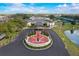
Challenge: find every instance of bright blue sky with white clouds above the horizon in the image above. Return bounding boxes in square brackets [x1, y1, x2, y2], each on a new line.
[0, 3, 79, 14]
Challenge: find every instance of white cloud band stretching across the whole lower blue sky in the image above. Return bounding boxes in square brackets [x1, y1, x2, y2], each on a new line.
[0, 3, 79, 14]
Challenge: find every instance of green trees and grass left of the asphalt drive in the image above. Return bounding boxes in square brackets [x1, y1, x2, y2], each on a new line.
[0, 19, 26, 47]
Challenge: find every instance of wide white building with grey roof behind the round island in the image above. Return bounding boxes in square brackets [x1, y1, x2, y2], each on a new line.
[27, 16, 55, 28]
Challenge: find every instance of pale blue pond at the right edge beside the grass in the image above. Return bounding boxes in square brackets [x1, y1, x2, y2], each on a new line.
[64, 30, 79, 46]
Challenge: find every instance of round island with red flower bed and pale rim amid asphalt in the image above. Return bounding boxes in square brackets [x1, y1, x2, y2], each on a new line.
[23, 31, 53, 50]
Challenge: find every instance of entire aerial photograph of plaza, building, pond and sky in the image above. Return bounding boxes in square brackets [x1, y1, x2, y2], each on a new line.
[0, 3, 79, 56]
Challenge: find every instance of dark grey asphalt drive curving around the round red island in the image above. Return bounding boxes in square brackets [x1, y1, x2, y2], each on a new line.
[0, 29, 69, 56]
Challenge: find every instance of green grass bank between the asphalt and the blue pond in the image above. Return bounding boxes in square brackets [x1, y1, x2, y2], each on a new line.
[53, 24, 79, 56]
